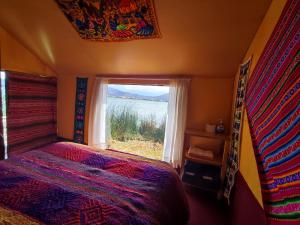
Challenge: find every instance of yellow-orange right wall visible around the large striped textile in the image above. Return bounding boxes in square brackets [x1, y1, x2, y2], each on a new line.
[234, 0, 286, 205]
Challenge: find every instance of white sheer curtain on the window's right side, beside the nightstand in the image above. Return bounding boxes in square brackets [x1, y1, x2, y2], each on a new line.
[163, 79, 189, 168]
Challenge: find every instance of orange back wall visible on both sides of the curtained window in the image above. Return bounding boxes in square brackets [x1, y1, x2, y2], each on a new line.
[58, 76, 233, 142]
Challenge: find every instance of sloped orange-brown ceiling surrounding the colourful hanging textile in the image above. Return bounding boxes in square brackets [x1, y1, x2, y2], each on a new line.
[0, 0, 271, 77]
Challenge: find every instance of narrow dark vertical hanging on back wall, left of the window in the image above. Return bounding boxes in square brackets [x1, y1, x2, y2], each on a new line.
[73, 77, 88, 144]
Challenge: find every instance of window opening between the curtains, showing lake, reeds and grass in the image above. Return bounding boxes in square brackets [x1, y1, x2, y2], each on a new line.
[106, 84, 169, 160]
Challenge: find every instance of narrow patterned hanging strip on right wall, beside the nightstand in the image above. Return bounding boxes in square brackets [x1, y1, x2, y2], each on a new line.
[224, 57, 252, 203]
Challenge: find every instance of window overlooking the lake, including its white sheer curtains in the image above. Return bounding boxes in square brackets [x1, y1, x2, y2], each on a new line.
[88, 77, 189, 167]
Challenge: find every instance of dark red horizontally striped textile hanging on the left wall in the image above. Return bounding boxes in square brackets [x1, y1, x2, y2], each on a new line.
[7, 72, 57, 155]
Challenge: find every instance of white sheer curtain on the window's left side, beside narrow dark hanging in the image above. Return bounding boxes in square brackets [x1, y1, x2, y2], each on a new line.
[88, 77, 108, 148]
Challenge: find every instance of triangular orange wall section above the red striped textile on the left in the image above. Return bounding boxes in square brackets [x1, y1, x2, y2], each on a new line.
[0, 27, 55, 76]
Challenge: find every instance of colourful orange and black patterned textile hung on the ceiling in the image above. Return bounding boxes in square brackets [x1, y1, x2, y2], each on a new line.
[55, 0, 160, 41]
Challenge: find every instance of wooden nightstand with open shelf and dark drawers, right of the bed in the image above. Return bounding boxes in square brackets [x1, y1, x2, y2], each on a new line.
[181, 130, 229, 198]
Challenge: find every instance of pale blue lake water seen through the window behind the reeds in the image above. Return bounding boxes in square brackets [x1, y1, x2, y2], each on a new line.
[107, 97, 168, 124]
